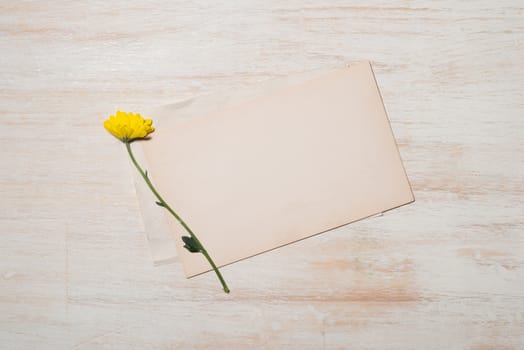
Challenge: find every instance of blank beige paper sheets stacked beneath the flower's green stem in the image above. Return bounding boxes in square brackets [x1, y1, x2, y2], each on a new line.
[138, 62, 414, 277]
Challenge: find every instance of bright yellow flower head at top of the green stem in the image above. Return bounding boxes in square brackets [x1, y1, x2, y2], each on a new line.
[104, 111, 155, 142]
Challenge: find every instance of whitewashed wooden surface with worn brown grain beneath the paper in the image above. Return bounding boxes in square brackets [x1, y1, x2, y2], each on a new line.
[0, 0, 524, 350]
